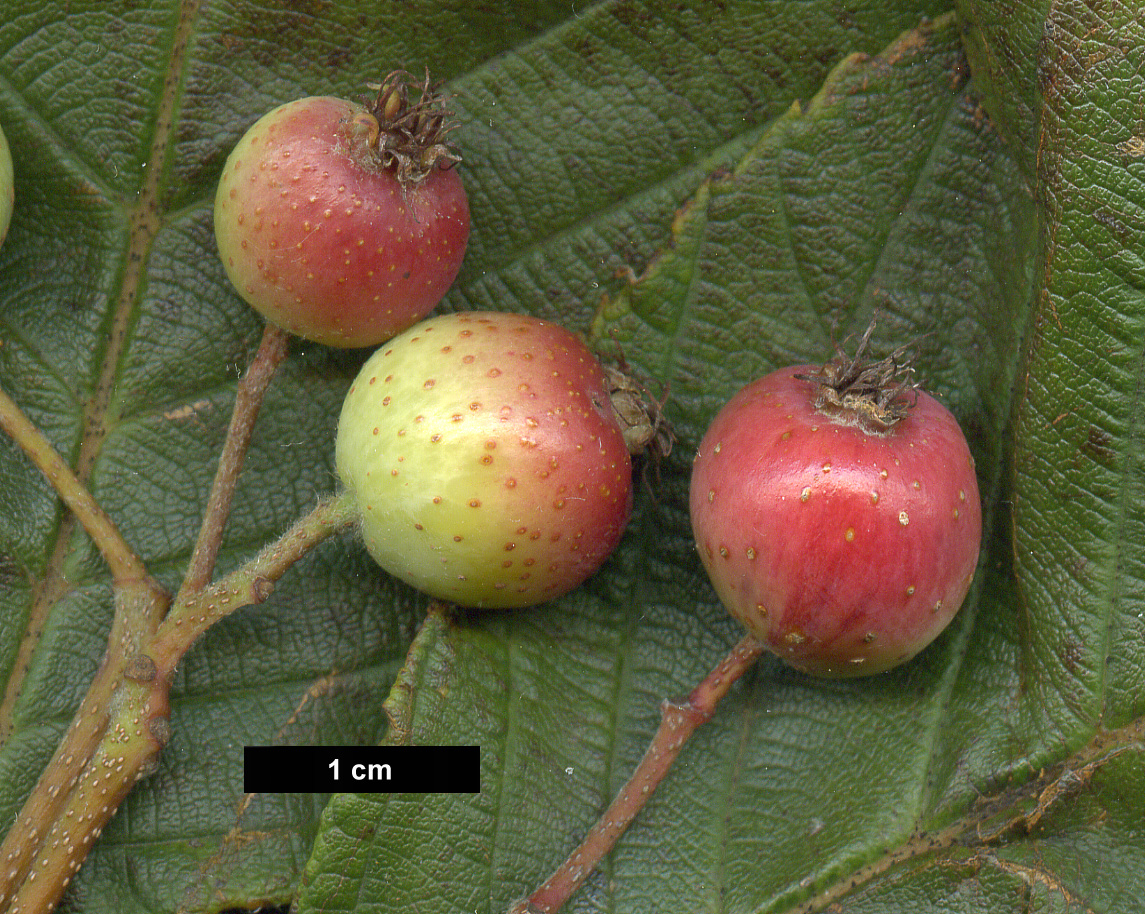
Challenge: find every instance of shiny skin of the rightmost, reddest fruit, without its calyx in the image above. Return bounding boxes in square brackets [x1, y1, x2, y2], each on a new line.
[689, 365, 982, 677]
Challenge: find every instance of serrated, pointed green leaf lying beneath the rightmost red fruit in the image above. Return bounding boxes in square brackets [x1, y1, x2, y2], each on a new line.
[301, 10, 1140, 912]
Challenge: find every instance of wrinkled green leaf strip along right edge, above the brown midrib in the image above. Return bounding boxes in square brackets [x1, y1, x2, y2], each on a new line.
[975, 3, 1145, 740]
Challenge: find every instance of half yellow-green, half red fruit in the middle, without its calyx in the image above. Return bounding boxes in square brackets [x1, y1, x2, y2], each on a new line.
[335, 313, 632, 608]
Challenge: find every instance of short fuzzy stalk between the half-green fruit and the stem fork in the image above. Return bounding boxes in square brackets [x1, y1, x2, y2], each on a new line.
[148, 494, 357, 678]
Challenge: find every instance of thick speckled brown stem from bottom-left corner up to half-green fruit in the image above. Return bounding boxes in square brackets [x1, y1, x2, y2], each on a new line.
[0, 495, 357, 914]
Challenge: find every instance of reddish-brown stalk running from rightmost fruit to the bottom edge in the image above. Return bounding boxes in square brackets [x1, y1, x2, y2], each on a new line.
[508, 635, 764, 914]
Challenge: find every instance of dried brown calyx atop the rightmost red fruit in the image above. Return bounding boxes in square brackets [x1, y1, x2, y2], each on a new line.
[796, 318, 918, 435]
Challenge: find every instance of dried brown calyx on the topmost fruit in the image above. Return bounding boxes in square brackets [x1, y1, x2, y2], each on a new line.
[362, 70, 461, 188]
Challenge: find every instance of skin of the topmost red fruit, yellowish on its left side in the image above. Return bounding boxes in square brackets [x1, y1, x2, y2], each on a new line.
[214, 96, 469, 348]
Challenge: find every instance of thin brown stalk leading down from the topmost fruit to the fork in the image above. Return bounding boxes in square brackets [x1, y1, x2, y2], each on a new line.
[175, 323, 290, 604]
